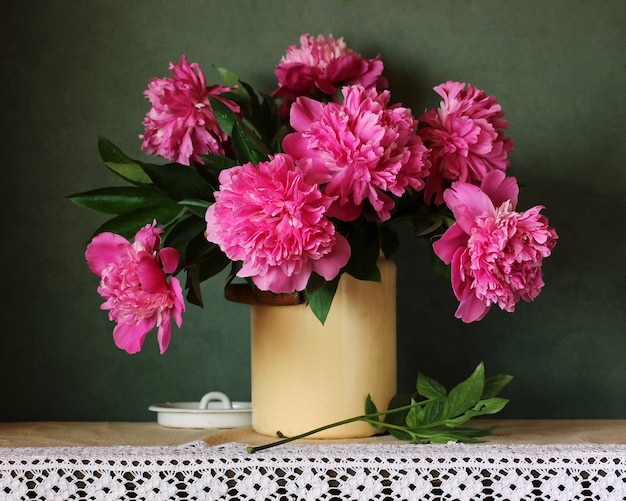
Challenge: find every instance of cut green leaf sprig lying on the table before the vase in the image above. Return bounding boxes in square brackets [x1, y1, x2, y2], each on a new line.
[247, 362, 513, 453]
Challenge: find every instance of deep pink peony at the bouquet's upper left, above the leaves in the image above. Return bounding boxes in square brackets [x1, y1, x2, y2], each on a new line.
[140, 56, 239, 165]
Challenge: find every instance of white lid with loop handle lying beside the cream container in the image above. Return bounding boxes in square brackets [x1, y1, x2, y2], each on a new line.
[149, 391, 252, 428]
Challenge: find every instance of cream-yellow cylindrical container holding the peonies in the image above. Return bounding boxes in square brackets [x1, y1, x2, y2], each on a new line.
[251, 259, 396, 438]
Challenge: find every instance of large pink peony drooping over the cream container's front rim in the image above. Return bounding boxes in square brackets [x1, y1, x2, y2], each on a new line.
[206, 154, 350, 293]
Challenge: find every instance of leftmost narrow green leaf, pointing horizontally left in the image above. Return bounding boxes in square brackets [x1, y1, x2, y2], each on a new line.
[68, 186, 171, 214]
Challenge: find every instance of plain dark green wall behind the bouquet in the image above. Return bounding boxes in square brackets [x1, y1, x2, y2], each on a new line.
[0, 0, 626, 421]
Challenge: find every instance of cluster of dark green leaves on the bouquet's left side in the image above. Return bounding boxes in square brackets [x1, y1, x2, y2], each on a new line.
[69, 138, 229, 306]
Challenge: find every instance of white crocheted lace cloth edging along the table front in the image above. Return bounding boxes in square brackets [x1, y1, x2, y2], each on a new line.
[0, 441, 626, 501]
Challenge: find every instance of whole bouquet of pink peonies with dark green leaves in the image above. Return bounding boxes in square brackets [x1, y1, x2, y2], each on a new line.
[70, 35, 557, 353]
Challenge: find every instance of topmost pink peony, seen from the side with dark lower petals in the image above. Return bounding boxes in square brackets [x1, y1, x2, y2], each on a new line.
[274, 34, 387, 102]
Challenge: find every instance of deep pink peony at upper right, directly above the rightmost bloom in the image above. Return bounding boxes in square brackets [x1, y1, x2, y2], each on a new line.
[418, 82, 513, 205]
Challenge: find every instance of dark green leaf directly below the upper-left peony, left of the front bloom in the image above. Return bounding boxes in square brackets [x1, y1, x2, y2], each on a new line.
[143, 164, 213, 201]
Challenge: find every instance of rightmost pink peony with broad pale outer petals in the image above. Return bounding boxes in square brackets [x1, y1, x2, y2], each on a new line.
[433, 171, 558, 322]
